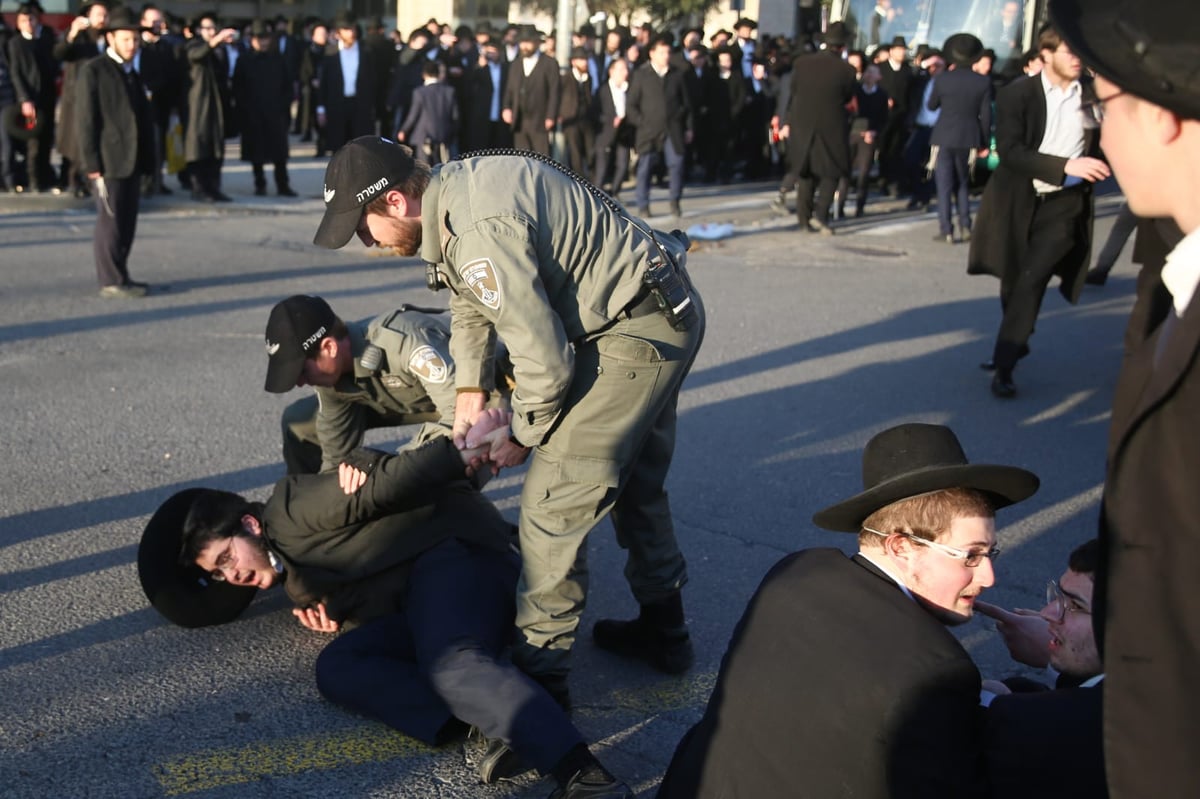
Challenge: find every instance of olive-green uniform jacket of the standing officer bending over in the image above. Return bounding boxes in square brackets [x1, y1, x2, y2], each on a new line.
[421, 156, 685, 446]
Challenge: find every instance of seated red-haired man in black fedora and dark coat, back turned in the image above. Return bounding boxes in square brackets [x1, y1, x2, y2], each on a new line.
[659, 423, 1038, 799]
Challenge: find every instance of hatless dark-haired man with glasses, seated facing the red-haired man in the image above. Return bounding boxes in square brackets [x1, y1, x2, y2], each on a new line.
[976, 539, 1108, 799]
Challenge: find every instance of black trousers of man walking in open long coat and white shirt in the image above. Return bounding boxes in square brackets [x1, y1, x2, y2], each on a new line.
[992, 188, 1091, 373]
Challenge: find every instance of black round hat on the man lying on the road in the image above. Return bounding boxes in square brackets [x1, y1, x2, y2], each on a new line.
[138, 488, 258, 627]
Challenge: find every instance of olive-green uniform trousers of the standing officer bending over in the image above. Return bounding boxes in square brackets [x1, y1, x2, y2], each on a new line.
[514, 284, 704, 675]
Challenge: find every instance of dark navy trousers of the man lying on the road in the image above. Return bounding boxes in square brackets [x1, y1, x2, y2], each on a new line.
[317, 539, 583, 774]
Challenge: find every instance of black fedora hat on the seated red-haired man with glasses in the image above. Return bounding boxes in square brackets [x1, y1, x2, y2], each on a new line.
[812, 423, 1039, 533]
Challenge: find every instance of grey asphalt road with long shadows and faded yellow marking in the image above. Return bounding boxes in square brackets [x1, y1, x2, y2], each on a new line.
[0, 147, 1134, 799]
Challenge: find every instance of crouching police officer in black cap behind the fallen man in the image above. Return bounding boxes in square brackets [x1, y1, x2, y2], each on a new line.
[266, 295, 465, 474]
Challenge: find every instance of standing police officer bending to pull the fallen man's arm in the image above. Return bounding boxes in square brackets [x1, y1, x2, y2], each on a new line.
[314, 137, 704, 704]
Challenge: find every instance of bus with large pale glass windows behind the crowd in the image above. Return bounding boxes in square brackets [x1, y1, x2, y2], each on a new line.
[829, 0, 1046, 73]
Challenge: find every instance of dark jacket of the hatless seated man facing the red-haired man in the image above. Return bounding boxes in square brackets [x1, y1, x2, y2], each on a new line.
[984, 687, 1109, 799]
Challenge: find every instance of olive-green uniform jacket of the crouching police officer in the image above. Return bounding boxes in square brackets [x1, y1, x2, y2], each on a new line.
[316, 305, 455, 471]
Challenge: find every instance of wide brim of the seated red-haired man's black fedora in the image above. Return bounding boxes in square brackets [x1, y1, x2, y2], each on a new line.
[812, 463, 1040, 533]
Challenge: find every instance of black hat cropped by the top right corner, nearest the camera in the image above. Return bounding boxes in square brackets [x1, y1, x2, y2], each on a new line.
[1050, 0, 1200, 119]
